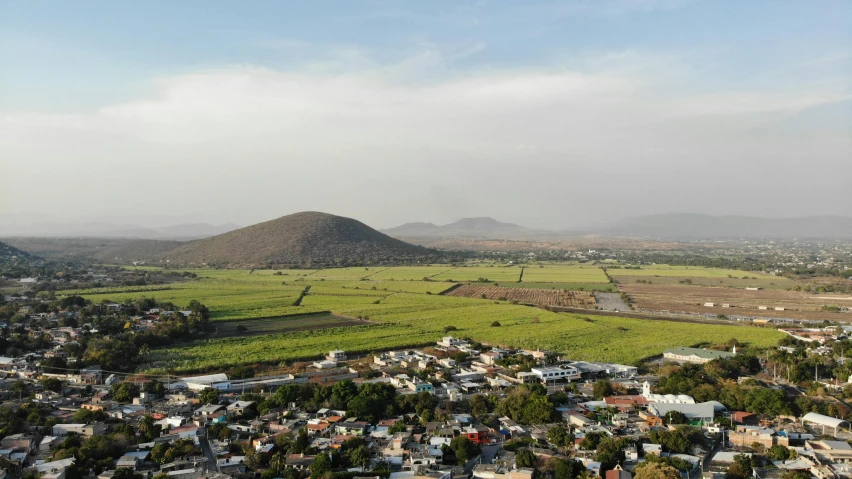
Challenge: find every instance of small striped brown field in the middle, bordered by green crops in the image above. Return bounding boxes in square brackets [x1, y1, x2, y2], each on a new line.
[447, 284, 595, 309]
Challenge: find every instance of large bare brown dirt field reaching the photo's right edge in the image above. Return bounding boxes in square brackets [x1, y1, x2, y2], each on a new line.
[620, 284, 852, 321]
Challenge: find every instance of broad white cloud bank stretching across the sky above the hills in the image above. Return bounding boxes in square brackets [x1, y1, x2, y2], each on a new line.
[0, 50, 850, 226]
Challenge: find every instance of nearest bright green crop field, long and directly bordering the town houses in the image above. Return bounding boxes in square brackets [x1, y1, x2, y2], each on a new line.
[141, 300, 783, 372]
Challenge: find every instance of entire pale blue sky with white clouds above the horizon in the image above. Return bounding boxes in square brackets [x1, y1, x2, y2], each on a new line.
[0, 0, 852, 233]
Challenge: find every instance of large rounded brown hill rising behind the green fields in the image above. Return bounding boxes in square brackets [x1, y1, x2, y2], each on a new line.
[159, 212, 437, 266]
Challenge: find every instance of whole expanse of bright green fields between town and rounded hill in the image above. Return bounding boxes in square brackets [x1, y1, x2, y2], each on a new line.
[73, 265, 782, 372]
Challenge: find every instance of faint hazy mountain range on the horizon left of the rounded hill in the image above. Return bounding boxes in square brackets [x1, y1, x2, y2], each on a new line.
[0, 221, 239, 239]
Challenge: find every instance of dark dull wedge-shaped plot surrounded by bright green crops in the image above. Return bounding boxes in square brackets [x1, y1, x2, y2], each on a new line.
[216, 314, 367, 338]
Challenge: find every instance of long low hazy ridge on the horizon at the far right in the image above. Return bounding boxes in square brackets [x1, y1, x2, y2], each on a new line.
[601, 213, 852, 238]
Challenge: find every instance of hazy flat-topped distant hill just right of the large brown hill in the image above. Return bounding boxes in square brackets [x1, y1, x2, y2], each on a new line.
[383, 217, 534, 239]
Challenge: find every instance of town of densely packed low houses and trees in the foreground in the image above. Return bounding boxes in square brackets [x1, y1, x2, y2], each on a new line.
[5, 297, 852, 479]
